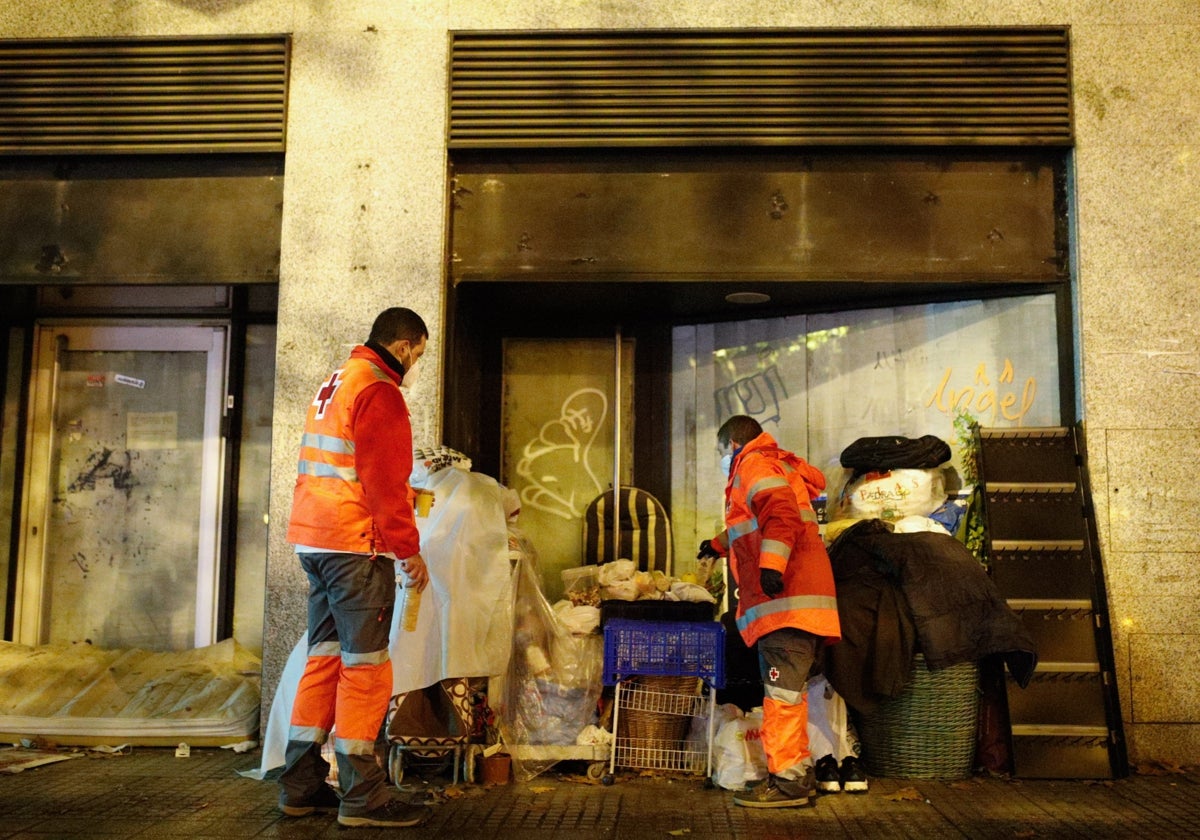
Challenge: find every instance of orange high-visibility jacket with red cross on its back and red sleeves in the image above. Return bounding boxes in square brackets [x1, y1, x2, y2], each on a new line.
[288, 346, 420, 558]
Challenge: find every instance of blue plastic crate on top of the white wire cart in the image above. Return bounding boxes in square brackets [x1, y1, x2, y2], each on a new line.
[604, 618, 725, 689]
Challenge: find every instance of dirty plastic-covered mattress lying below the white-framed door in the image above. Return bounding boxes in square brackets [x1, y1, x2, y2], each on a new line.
[0, 638, 262, 746]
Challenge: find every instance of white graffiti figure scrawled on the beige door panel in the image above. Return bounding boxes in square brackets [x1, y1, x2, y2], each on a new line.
[517, 388, 608, 520]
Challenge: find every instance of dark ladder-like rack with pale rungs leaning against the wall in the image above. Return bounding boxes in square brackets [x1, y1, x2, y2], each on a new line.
[976, 426, 1129, 779]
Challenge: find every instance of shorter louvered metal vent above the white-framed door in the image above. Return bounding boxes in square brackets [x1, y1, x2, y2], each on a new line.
[0, 36, 289, 155]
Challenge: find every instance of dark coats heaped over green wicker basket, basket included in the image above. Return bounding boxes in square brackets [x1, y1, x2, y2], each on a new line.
[824, 520, 1037, 779]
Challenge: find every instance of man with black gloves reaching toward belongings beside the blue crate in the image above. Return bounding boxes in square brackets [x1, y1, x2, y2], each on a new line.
[700, 414, 841, 808]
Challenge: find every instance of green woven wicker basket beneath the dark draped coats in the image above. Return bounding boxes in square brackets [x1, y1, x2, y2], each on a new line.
[856, 654, 979, 779]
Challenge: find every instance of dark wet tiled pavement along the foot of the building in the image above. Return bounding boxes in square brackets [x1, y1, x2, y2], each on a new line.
[0, 748, 1200, 840]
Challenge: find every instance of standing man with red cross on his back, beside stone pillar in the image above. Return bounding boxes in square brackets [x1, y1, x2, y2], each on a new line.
[280, 307, 428, 828]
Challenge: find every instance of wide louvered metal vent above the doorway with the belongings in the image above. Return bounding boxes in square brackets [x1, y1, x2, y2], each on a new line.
[449, 28, 1072, 149]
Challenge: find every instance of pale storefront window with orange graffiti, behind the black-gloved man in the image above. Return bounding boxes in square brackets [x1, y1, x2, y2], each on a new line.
[671, 294, 1062, 573]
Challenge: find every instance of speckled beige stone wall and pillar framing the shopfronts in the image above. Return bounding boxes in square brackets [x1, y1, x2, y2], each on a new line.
[0, 0, 1200, 762]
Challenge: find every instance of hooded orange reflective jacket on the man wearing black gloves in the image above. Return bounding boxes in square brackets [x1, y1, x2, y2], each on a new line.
[713, 432, 841, 644]
